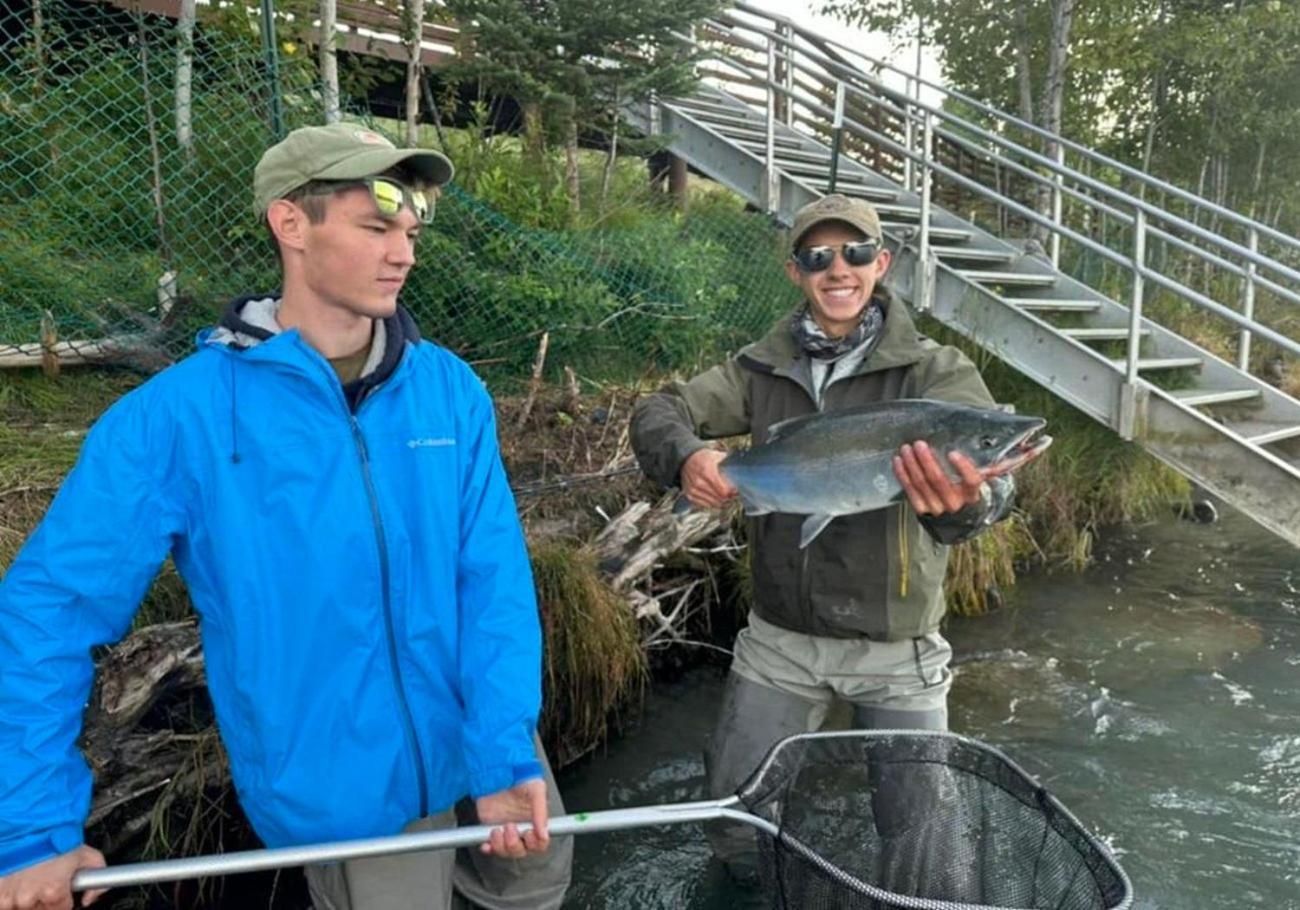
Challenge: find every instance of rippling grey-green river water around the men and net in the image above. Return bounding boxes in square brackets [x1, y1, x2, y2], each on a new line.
[560, 514, 1300, 910]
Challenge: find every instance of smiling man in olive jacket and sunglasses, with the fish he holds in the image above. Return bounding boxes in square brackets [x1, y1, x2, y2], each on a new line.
[632, 195, 1047, 875]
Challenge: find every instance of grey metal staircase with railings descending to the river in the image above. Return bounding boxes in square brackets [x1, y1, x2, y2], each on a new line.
[629, 4, 1300, 546]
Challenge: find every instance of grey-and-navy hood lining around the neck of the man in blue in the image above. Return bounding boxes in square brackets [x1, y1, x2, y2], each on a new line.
[202, 294, 420, 407]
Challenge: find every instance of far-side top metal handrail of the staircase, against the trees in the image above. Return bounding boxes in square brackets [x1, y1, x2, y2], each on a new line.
[723, 1, 1300, 251]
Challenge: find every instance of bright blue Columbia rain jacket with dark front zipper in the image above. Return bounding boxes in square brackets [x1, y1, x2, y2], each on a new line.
[0, 299, 542, 874]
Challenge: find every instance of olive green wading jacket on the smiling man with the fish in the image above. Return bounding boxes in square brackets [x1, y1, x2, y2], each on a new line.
[632, 289, 1010, 641]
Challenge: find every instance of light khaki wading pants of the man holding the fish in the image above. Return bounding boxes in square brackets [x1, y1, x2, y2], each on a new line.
[705, 614, 953, 876]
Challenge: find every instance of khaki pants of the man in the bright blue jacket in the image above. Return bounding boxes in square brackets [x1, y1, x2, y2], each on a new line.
[306, 741, 573, 910]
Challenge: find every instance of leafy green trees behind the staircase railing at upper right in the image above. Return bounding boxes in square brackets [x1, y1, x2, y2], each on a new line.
[823, 0, 1300, 231]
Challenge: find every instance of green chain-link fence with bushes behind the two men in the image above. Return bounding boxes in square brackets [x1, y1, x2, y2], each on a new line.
[0, 0, 792, 387]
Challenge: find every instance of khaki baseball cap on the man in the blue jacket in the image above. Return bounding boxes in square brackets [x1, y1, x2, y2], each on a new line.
[252, 122, 455, 215]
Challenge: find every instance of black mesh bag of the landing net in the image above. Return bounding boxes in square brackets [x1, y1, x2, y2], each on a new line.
[737, 731, 1131, 910]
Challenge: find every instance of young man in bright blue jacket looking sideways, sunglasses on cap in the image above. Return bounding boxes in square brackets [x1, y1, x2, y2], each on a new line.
[0, 124, 571, 910]
